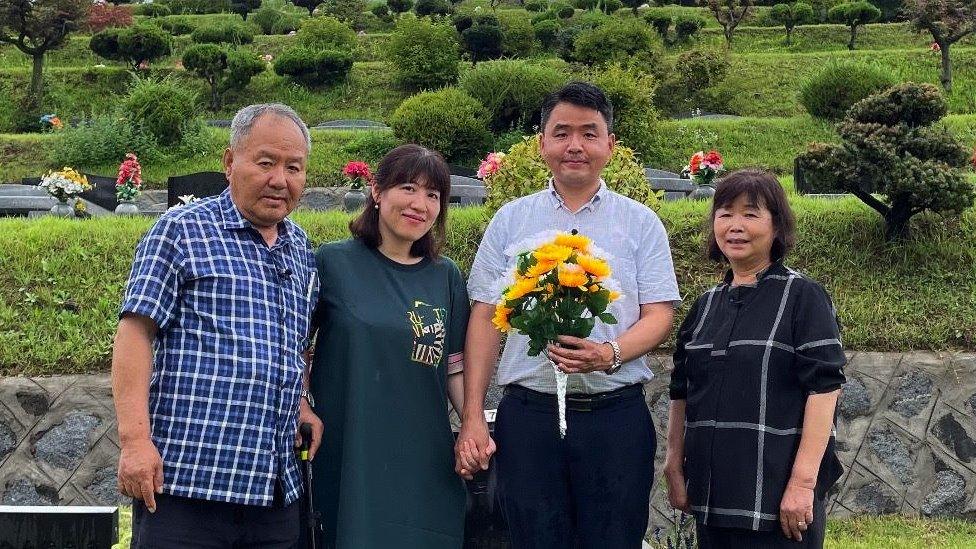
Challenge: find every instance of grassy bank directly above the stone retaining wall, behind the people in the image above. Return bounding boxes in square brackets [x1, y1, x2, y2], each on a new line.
[0, 198, 976, 376]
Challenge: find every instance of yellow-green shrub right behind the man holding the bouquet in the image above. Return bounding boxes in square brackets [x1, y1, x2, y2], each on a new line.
[485, 134, 660, 211]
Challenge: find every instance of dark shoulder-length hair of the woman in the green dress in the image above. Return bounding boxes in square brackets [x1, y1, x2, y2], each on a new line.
[349, 144, 451, 259]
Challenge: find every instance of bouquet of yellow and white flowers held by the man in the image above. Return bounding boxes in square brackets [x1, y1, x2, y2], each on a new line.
[492, 231, 620, 436]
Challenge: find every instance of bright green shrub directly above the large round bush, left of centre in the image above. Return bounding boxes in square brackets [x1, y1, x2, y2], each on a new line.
[387, 16, 461, 90]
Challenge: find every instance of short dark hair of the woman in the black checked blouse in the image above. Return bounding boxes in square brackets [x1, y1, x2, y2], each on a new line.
[706, 169, 796, 261]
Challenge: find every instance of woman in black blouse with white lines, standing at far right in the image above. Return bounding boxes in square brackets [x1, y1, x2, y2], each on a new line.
[664, 170, 846, 549]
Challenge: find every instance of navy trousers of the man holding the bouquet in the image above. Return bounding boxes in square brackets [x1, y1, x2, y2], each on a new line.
[495, 386, 656, 549]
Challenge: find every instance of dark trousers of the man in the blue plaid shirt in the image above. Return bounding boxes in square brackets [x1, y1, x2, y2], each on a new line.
[130, 494, 301, 549]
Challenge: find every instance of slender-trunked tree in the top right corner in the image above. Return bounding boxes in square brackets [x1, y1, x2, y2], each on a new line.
[904, 0, 976, 93]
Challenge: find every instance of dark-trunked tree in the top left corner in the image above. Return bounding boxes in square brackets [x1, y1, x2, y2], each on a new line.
[0, 0, 91, 105]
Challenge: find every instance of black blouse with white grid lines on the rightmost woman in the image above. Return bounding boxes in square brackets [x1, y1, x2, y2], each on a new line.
[670, 263, 846, 530]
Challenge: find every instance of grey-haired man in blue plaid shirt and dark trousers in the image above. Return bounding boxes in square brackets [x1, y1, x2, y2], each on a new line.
[112, 104, 322, 548]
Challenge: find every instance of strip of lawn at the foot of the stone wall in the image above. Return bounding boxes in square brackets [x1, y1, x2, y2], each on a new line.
[112, 507, 976, 549]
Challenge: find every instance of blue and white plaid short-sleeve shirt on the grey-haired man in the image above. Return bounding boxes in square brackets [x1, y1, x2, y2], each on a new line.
[120, 191, 318, 506]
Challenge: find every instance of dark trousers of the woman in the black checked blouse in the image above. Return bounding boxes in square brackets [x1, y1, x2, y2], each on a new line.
[696, 499, 827, 549]
